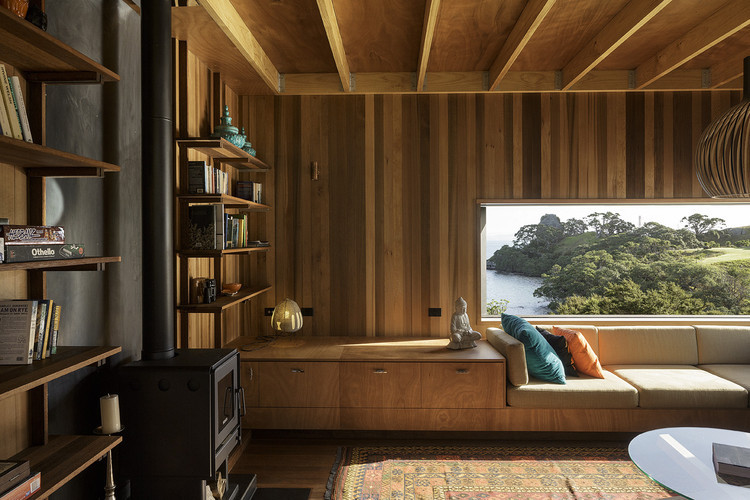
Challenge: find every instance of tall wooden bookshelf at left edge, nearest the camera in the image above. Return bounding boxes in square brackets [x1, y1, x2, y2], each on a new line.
[0, 8, 122, 499]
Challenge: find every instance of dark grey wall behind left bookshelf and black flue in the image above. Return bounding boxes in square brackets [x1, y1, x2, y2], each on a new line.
[46, 0, 142, 500]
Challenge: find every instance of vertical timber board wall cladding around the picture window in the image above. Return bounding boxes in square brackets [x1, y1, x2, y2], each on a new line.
[239, 91, 741, 337]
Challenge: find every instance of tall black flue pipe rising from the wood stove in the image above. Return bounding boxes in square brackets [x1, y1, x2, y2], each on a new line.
[141, 0, 175, 360]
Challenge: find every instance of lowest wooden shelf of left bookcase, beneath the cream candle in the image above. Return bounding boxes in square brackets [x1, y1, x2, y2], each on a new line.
[11, 436, 122, 500]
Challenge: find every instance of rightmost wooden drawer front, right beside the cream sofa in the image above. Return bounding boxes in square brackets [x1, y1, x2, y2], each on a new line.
[421, 363, 505, 408]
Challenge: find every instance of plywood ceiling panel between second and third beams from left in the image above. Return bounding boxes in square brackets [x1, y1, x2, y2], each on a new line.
[333, 0, 425, 72]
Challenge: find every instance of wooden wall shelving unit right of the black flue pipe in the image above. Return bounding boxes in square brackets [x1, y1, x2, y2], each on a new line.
[177, 138, 271, 347]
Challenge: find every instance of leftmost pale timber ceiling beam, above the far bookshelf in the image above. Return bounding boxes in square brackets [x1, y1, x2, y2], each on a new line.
[201, 0, 279, 93]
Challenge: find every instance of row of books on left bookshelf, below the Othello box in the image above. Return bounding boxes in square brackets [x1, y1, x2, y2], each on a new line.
[0, 299, 62, 365]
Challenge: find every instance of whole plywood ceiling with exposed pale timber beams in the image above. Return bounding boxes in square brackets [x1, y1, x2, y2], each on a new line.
[172, 0, 750, 94]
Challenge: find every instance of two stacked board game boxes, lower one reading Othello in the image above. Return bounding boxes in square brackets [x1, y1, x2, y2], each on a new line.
[0, 224, 85, 263]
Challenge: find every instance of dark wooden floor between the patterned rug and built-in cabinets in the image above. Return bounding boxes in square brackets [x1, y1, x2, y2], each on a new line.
[231, 431, 635, 500]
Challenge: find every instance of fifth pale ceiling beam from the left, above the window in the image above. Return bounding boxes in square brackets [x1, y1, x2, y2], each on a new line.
[562, 0, 672, 90]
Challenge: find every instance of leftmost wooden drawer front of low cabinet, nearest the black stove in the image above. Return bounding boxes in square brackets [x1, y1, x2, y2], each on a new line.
[258, 362, 339, 408]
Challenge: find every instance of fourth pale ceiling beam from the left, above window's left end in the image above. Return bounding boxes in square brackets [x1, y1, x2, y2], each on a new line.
[490, 0, 556, 90]
